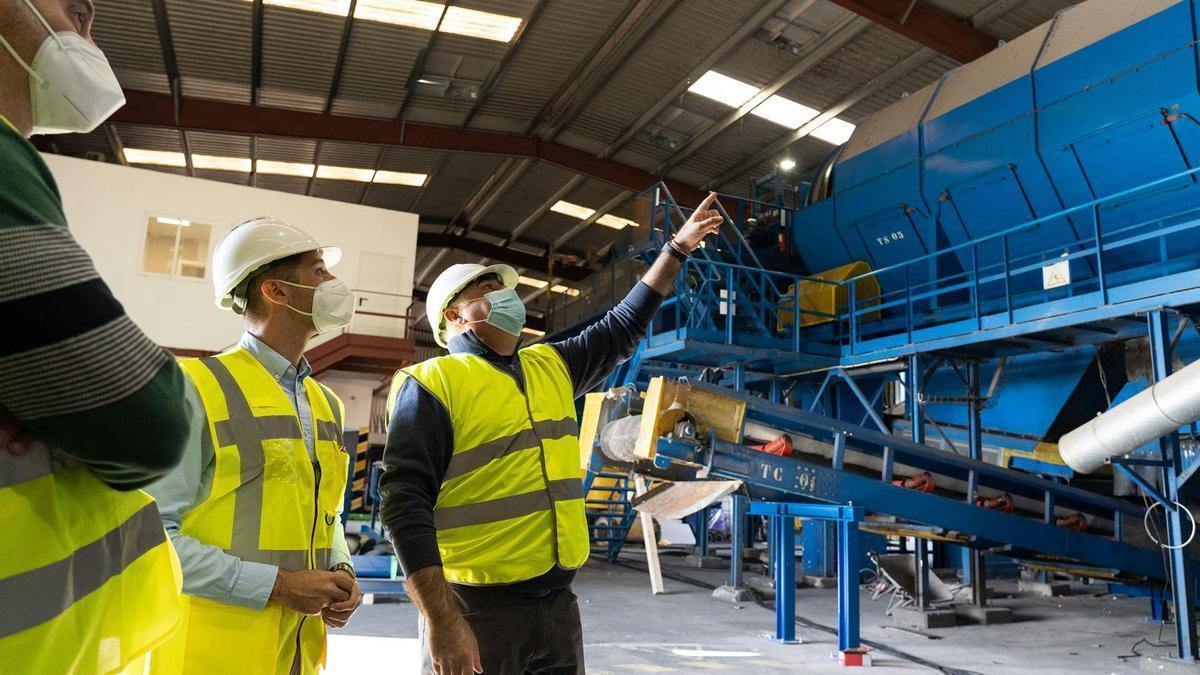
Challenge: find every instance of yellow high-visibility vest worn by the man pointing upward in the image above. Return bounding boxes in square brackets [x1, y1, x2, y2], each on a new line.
[388, 345, 589, 585]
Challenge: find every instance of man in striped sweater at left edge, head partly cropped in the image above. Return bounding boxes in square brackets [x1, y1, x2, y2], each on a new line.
[0, 0, 190, 673]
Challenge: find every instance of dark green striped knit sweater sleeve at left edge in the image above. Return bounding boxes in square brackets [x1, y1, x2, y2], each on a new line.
[0, 118, 190, 490]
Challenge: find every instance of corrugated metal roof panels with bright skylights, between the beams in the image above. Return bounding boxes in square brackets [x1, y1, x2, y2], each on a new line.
[54, 0, 1099, 284]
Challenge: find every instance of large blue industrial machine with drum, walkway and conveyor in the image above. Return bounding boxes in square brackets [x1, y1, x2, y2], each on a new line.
[552, 0, 1200, 659]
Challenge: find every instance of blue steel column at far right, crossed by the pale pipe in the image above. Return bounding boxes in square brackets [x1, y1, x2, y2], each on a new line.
[1146, 310, 1196, 661]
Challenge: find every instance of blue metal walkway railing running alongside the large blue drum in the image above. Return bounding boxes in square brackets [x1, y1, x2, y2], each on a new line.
[614, 163, 1200, 354]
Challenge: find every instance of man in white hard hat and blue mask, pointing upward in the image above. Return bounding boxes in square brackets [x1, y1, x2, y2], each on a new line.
[379, 195, 721, 675]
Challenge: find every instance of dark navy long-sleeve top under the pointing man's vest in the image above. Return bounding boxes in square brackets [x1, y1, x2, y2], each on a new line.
[379, 283, 662, 592]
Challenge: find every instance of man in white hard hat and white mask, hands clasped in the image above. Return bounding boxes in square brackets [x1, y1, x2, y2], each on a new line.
[149, 217, 361, 674]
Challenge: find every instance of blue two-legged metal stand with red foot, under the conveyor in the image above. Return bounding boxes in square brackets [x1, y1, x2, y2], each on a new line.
[750, 502, 863, 652]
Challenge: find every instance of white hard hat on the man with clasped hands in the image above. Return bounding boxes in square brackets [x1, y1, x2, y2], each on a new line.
[212, 217, 342, 313]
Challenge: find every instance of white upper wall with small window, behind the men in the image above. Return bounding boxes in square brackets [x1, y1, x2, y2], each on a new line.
[43, 154, 418, 352]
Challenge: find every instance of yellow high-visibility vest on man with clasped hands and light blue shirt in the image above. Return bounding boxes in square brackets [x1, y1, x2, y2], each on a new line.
[150, 347, 349, 675]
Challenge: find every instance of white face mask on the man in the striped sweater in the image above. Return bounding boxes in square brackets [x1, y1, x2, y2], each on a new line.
[0, 0, 125, 135]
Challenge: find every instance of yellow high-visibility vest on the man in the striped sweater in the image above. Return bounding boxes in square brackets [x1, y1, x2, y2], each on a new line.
[0, 449, 182, 675]
